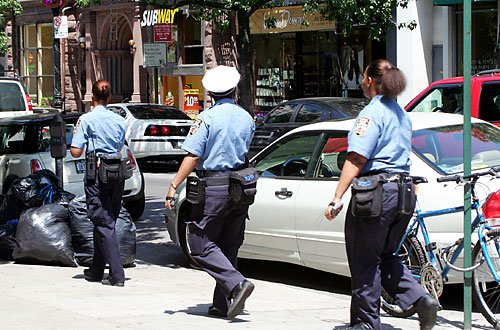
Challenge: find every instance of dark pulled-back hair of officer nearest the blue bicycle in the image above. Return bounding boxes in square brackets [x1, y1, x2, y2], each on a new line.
[366, 60, 406, 99]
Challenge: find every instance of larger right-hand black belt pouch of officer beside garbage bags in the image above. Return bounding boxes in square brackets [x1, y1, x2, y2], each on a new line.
[93, 154, 133, 183]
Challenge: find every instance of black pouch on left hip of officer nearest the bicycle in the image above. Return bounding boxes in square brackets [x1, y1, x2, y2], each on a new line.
[351, 175, 385, 218]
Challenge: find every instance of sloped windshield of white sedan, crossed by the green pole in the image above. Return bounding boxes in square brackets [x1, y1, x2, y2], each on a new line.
[412, 124, 500, 174]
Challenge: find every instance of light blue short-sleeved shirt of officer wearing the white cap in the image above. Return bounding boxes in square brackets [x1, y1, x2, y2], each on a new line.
[182, 98, 255, 171]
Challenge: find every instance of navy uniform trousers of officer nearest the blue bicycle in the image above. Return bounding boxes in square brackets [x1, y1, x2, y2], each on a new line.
[345, 182, 426, 330]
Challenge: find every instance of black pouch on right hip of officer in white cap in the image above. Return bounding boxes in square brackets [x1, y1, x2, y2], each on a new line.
[229, 167, 259, 205]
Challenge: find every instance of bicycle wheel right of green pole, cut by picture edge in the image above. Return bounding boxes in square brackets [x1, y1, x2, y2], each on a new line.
[472, 229, 500, 329]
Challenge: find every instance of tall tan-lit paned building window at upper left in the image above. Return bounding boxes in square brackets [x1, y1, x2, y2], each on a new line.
[20, 23, 54, 106]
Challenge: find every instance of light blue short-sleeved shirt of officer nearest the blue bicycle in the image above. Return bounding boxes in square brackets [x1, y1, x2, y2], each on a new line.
[348, 95, 412, 173]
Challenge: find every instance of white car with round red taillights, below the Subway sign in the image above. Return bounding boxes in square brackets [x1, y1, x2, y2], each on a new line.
[107, 103, 193, 161]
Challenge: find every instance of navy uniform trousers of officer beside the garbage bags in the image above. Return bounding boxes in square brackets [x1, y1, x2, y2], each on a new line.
[85, 179, 125, 282]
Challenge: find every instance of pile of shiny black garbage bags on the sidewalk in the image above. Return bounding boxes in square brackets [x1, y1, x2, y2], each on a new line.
[0, 170, 136, 267]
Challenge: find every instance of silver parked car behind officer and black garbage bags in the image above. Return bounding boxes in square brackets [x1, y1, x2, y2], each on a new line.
[0, 113, 145, 219]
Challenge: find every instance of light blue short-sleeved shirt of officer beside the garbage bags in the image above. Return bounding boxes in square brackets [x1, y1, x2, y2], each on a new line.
[71, 105, 125, 154]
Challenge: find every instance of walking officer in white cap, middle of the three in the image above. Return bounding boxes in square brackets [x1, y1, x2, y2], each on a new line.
[165, 65, 255, 318]
